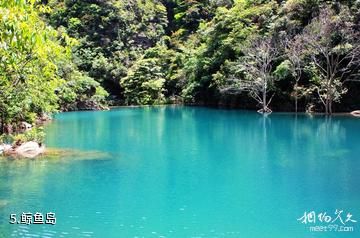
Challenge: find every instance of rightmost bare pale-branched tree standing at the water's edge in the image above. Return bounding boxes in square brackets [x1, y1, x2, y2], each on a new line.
[302, 7, 360, 114]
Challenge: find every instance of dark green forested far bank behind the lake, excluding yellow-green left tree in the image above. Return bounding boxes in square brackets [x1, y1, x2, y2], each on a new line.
[45, 0, 360, 113]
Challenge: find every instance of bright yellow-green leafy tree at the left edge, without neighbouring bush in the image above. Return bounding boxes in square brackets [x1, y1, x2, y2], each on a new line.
[0, 1, 67, 130]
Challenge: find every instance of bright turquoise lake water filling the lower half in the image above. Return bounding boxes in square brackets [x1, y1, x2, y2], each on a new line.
[0, 106, 360, 238]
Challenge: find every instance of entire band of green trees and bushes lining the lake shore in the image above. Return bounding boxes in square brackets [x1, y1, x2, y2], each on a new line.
[0, 0, 360, 136]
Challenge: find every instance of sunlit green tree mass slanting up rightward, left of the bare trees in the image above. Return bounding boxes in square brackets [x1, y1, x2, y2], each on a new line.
[183, 0, 278, 103]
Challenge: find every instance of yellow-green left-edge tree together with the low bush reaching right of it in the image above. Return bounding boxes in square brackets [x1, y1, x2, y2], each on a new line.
[0, 0, 105, 132]
